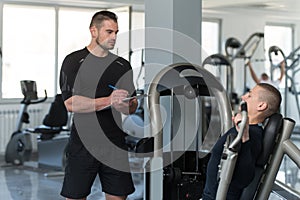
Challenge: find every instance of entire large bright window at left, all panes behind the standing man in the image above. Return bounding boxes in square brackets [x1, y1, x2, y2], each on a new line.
[1, 4, 130, 99]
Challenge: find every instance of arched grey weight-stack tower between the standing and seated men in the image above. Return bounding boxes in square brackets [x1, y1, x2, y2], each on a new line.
[144, 64, 231, 200]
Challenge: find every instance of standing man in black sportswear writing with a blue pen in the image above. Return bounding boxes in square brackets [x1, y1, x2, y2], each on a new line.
[60, 11, 137, 200]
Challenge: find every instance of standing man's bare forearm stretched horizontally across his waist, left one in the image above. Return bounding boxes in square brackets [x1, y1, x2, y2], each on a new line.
[65, 95, 110, 113]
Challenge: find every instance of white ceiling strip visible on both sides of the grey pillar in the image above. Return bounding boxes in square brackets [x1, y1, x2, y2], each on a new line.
[0, 0, 300, 16]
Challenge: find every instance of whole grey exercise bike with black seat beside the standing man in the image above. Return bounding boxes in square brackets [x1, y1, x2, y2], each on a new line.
[5, 80, 70, 170]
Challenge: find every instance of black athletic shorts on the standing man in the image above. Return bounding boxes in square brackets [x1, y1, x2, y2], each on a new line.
[61, 140, 135, 199]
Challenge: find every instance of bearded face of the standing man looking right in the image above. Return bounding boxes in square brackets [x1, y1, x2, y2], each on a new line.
[96, 20, 119, 50]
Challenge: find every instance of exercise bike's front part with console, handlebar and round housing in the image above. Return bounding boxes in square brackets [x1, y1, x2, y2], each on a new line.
[5, 80, 47, 165]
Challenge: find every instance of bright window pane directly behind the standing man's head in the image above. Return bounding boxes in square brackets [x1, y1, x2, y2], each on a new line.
[57, 7, 130, 91]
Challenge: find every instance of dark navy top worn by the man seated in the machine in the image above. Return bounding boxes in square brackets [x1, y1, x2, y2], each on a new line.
[203, 124, 263, 200]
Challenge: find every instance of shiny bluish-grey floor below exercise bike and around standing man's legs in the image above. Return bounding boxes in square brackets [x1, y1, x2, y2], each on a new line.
[0, 153, 144, 200]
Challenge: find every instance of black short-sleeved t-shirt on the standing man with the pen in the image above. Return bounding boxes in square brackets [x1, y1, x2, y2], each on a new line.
[60, 48, 135, 145]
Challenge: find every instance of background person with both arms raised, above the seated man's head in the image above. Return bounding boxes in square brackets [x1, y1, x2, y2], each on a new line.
[246, 61, 285, 89]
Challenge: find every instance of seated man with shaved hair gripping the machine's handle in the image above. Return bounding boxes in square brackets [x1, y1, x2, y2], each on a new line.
[203, 83, 281, 200]
